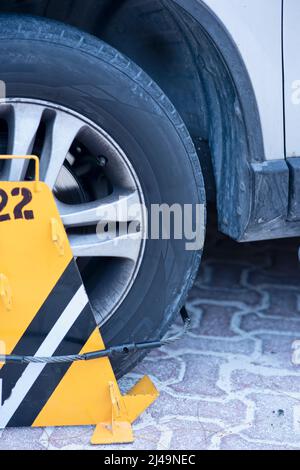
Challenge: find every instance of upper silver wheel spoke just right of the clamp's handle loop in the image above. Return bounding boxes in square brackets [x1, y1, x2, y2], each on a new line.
[41, 114, 84, 188]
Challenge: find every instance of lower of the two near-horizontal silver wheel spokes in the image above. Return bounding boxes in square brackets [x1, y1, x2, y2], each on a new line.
[69, 232, 141, 261]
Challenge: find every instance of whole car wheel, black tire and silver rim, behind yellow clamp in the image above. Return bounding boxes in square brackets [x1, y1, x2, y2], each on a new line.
[0, 15, 205, 375]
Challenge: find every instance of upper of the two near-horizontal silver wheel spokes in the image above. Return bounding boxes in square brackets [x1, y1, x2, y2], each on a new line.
[57, 190, 142, 227]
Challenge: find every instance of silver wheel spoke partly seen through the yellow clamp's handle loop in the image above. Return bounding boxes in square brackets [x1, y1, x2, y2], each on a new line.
[2, 103, 43, 181]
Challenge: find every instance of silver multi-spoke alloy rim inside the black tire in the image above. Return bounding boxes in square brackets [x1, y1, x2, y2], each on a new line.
[0, 98, 146, 325]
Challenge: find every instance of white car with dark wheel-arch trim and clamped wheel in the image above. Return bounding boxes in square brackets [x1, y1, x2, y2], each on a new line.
[0, 0, 300, 374]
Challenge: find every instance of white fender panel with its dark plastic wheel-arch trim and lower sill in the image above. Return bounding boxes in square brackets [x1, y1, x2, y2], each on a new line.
[174, 0, 300, 242]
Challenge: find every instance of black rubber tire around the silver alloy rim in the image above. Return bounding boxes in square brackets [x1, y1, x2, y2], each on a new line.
[0, 15, 205, 376]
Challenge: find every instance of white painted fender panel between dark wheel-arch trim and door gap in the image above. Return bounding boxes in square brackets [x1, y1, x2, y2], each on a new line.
[200, 0, 284, 160]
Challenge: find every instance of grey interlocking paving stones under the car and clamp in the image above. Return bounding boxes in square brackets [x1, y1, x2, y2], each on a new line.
[0, 233, 300, 450]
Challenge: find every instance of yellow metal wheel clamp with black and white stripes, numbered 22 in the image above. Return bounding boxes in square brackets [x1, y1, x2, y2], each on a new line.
[0, 156, 158, 444]
